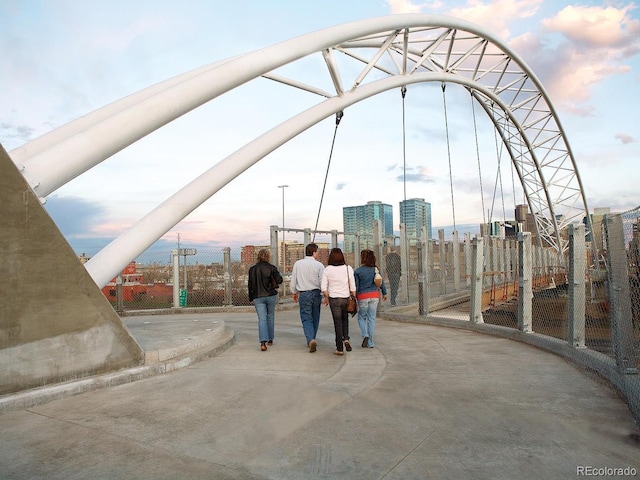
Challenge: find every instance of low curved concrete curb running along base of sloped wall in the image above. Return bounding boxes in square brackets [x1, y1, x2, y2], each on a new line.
[0, 322, 235, 415]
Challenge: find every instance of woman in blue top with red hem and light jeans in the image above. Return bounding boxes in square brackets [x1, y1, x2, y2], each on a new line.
[355, 249, 387, 348]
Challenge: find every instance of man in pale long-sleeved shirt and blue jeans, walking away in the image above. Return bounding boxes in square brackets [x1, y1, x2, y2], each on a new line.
[291, 243, 324, 353]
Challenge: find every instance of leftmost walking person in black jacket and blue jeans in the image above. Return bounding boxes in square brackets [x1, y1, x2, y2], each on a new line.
[248, 248, 282, 352]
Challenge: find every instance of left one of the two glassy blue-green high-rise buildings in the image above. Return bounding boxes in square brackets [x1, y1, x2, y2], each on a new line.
[342, 201, 393, 253]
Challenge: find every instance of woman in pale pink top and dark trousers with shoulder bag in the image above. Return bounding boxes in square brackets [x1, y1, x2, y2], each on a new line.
[320, 248, 356, 355]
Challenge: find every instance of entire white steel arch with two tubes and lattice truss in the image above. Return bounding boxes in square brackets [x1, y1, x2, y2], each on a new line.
[10, 14, 590, 285]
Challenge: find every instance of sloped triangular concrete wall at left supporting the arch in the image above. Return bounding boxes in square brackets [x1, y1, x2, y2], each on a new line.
[0, 145, 144, 395]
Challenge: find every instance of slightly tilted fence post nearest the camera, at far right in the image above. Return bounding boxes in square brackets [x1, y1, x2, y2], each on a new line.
[604, 214, 638, 374]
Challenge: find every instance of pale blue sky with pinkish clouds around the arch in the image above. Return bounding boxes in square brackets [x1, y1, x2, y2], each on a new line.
[0, 0, 640, 254]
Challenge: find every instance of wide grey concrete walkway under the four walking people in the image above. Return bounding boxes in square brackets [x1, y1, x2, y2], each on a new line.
[0, 308, 640, 480]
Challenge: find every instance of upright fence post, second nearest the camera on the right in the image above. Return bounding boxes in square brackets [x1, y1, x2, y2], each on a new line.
[567, 223, 587, 348]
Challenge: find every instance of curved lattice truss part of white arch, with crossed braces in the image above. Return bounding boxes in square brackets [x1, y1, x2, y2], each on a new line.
[264, 22, 590, 255]
